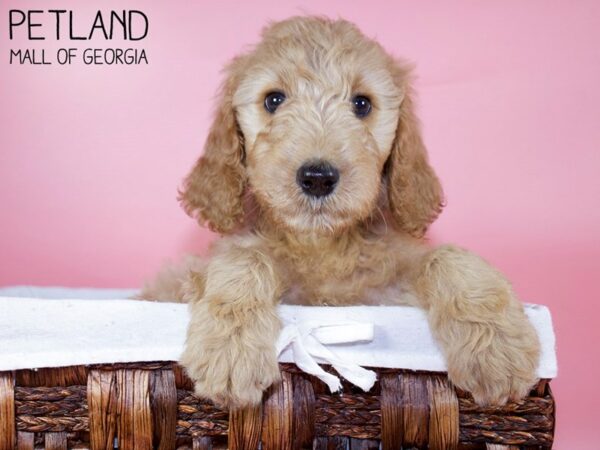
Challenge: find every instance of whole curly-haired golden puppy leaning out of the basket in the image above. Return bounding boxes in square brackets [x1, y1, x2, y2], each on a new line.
[145, 17, 539, 407]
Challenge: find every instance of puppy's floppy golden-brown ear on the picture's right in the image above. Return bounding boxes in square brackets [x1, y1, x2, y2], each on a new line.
[387, 65, 443, 237]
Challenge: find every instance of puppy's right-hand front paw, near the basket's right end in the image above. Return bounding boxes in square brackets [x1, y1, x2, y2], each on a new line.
[448, 330, 539, 406]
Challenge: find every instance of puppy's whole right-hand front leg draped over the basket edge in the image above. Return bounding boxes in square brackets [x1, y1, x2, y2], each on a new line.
[416, 246, 540, 405]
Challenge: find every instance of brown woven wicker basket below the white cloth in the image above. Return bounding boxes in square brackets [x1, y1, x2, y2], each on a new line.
[0, 362, 554, 450]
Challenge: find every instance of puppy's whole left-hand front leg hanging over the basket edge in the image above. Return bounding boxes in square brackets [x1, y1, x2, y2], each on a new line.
[181, 240, 281, 408]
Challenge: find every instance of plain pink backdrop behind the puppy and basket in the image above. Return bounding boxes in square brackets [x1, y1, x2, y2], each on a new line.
[0, 0, 600, 449]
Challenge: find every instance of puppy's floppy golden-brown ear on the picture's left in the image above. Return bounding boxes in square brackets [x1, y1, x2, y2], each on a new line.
[179, 58, 246, 234]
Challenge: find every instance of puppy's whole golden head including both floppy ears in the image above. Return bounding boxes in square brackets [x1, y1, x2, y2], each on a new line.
[180, 18, 442, 236]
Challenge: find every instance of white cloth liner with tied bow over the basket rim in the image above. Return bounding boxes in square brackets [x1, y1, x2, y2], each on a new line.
[0, 288, 557, 388]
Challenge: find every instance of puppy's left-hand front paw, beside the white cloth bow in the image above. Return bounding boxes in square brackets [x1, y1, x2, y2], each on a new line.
[181, 342, 280, 409]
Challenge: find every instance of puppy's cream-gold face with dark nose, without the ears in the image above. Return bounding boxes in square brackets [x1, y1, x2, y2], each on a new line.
[233, 22, 403, 232]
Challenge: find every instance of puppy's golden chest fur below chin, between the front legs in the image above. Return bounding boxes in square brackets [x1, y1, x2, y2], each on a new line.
[264, 229, 420, 306]
